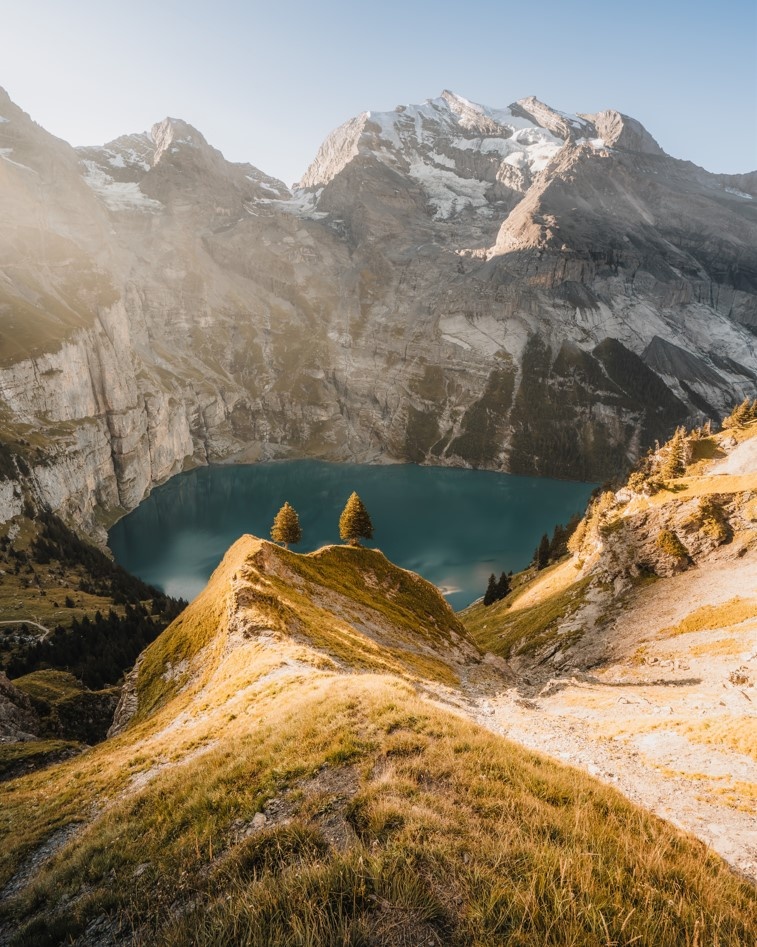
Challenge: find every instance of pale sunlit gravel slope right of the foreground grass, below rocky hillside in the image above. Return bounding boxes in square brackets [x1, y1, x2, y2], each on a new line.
[452, 544, 757, 883]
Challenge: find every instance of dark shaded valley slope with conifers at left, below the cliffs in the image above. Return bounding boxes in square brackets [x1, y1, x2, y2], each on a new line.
[0, 508, 184, 778]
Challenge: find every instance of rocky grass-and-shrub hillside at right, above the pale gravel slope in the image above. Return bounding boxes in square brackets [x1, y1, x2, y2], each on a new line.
[460, 409, 757, 666]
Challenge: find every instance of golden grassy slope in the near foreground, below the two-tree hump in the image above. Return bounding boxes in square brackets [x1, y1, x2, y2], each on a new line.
[3, 675, 757, 947]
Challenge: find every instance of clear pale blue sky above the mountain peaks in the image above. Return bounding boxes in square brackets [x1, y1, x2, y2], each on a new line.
[0, 0, 757, 183]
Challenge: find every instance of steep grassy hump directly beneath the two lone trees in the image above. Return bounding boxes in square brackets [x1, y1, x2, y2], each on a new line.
[131, 536, 476, 719]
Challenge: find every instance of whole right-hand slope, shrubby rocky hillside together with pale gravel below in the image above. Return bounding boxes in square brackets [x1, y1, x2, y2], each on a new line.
[461, 422, 757, 881]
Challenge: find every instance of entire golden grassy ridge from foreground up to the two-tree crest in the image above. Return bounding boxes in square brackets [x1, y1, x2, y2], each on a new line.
[0, 536, 757, 947]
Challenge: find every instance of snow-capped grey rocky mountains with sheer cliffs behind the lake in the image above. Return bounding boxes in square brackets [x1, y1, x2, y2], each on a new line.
[0, 86, 757, 528]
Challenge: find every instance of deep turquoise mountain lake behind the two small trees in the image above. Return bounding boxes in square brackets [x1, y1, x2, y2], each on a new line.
[109, 460, 594, 609]
